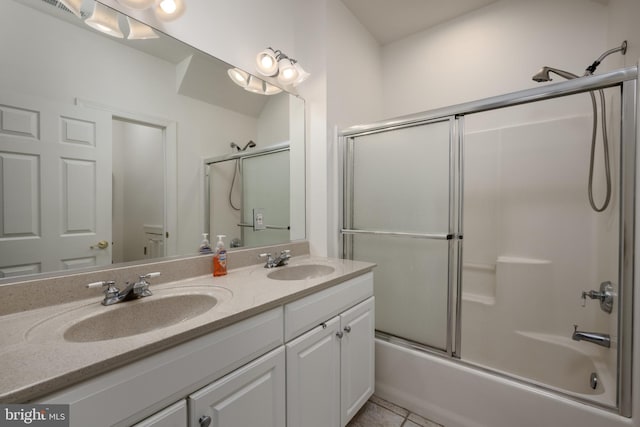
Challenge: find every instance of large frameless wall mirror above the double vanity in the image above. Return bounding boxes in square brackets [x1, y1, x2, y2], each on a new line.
[0, 0, 305, 282]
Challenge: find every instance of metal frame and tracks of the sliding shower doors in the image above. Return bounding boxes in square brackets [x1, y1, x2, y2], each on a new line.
[338, 66, 638, 417]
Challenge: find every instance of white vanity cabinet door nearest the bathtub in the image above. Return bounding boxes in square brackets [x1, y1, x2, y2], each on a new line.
[340, 297, 375, 426]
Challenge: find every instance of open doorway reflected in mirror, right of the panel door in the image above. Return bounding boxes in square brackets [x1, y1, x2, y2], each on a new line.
[113, 118, 165, 263]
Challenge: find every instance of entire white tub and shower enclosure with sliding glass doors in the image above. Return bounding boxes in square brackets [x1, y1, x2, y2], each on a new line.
[340, 64, 638, 427]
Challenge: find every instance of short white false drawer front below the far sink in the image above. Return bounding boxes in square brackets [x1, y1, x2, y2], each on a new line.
[284, 272, 373, 342]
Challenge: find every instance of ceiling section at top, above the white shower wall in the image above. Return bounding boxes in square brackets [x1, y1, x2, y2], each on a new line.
[342, 0, 497, 45]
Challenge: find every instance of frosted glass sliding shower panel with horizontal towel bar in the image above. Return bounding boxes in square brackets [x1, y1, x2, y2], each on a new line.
[342, 118, 457, 352]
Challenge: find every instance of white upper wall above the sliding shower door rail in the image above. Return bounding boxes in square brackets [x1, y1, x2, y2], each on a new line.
[382, 0, 608, 117]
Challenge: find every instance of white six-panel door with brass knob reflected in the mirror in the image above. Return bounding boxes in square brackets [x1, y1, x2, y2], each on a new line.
[0, 94, 112, 277]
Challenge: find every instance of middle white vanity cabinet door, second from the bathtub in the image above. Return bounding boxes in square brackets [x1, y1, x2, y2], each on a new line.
[286, 316, 340, 427]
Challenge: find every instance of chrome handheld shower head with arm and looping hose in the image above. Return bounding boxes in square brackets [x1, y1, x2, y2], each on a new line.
[532, 40, 627, 212]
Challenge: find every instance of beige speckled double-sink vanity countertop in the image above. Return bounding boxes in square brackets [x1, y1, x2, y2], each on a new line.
[0, 256, 374, 403]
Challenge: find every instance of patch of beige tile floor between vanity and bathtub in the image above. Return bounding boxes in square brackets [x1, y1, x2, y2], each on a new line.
[347, 396, 443, 427]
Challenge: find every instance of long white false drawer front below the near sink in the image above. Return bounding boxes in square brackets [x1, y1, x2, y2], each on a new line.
[39, 307, 283, 427]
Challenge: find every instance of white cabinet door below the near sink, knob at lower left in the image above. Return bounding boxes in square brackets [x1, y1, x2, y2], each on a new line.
[189, 346, 286, 427]
